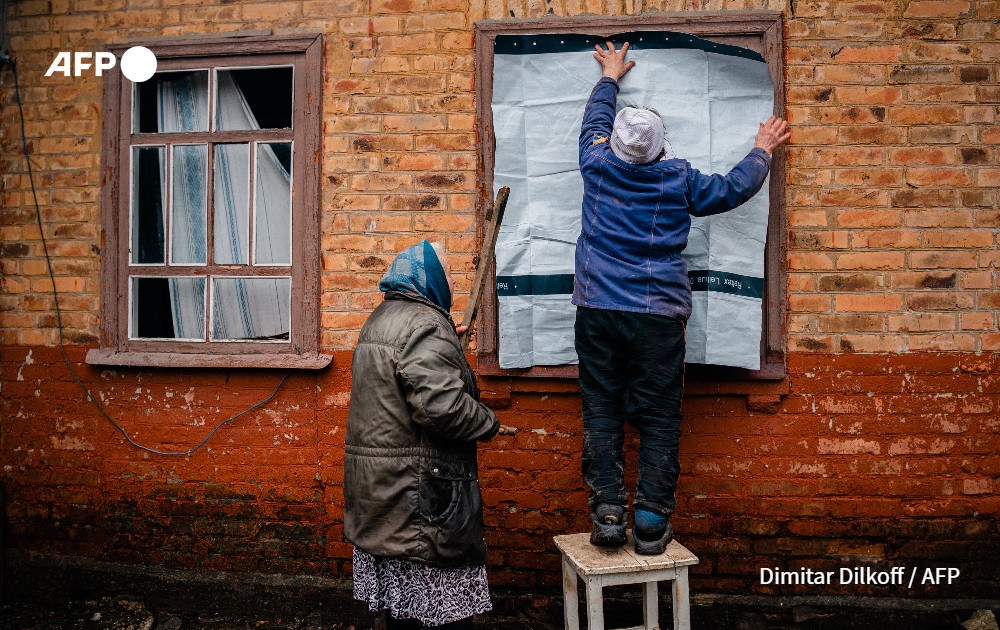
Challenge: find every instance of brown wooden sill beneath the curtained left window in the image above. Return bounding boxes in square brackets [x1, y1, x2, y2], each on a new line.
[86, 348, 333, 370]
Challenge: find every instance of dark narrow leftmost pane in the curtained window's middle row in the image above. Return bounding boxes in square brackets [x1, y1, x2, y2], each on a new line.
[129, 147, 167, 265]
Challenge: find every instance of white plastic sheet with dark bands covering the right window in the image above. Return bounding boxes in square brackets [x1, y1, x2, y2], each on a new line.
[493, 31, 774, 369]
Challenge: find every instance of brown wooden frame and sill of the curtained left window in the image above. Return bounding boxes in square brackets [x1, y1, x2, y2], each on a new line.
[87, 32, 332, 369]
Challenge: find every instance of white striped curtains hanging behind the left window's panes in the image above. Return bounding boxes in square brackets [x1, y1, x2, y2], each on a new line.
[157, 71, 291, 339]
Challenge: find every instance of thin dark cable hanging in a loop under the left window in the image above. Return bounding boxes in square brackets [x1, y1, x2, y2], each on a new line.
[0, 55, 292, 457]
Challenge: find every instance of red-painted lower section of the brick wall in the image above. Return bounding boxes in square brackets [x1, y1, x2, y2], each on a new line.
[0, 347, 1000, 597]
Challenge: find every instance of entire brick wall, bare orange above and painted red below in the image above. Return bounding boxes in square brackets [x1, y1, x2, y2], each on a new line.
[0, 0, 1000, 608]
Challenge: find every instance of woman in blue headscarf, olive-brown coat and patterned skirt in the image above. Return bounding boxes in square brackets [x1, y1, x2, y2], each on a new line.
[344, 241, 500, 630]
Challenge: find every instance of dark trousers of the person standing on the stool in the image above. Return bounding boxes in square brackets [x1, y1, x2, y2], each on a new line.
[576, 307, 684, 516]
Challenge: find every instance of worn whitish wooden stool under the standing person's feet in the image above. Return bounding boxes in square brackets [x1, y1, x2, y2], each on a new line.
[554, 532, 698, 630]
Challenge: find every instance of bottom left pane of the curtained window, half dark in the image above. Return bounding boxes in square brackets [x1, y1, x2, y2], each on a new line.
[129, 277, 205, 341]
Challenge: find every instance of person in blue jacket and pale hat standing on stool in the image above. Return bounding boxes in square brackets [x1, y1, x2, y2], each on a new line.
[573, 42, 789, 555]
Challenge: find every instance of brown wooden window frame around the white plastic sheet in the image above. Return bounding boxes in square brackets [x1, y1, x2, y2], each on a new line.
[475, 11, 787, 380]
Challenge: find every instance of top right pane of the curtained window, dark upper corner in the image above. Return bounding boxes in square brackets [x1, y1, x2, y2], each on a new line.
[215, 67, 292, 131]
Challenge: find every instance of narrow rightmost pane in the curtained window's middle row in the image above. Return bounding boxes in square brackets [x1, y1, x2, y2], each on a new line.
[253, 142, 292, 265]
